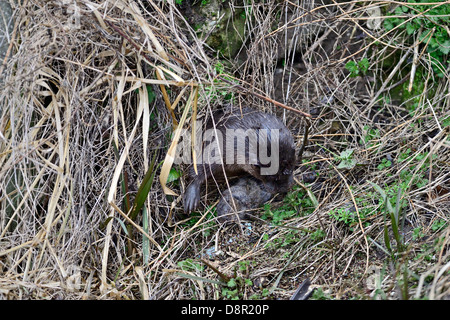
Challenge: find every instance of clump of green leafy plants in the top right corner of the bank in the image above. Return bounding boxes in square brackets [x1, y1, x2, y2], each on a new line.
[383, 0, 450, 77]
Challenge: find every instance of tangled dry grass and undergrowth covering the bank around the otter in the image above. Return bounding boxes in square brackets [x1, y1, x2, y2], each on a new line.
[0, 0, 450, 299]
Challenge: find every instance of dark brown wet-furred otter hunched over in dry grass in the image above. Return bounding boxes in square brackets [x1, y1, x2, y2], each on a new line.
[183, 107, 296, 214]
